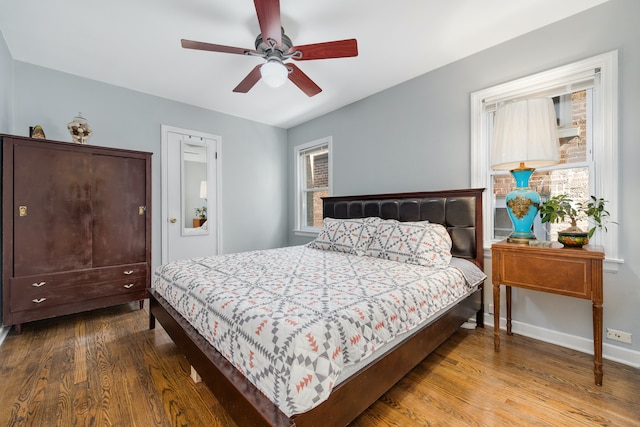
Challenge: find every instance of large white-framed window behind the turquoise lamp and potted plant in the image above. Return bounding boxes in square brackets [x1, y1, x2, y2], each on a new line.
[471, 51, 622, 271]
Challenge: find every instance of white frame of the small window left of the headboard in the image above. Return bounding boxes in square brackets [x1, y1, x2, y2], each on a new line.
[293, 136, 333, 237]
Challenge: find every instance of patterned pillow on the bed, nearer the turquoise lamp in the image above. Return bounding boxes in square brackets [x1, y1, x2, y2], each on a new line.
[366, 220, 451, 267]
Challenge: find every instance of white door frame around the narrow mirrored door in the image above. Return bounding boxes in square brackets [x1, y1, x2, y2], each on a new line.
[160, 125, 222, 264]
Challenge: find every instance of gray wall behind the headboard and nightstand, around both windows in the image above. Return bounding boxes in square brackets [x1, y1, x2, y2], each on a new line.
[288, 0, 640, 365]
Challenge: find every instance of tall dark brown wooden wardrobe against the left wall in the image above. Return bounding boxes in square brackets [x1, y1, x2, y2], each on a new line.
[0, 135, 151, 332]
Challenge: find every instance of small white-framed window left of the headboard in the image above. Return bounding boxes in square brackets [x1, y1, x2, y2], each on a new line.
[294, 137, 331, 235]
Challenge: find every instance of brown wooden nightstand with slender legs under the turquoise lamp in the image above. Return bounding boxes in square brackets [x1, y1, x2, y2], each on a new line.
[491, 241, 604, 385]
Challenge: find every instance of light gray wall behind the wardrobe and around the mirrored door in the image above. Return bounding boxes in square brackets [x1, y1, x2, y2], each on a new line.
[10, 61, 287, 266]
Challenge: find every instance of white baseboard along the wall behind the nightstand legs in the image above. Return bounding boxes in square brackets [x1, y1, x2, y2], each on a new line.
[484, 313, 640, 369]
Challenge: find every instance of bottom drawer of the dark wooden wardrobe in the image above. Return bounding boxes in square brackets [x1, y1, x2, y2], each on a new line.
[11, 275, 147, 311]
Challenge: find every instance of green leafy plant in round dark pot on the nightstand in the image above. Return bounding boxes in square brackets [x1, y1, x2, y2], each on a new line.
[540, 194, 609, 247]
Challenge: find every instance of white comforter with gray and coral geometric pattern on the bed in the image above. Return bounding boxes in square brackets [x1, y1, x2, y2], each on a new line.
[153, 246, 474, 416]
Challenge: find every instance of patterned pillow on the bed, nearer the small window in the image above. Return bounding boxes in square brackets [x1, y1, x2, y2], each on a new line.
[308, 217, 382, 255]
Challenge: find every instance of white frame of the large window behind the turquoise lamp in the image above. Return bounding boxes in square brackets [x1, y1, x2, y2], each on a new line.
[471, 50, 624, 272]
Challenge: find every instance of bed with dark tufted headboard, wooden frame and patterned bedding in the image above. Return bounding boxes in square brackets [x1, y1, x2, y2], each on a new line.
[149, 189, 483, 426]
